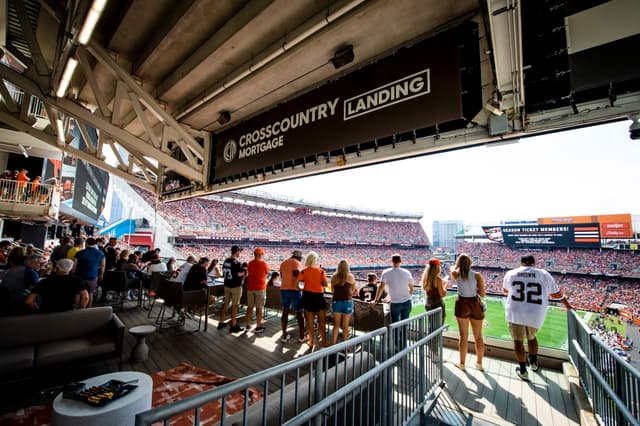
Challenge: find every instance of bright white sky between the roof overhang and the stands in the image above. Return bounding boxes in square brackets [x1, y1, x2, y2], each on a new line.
[256, 121, 640, 237]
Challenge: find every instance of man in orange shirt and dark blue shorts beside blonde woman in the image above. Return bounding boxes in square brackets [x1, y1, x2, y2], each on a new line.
[280, 250, 306, 343]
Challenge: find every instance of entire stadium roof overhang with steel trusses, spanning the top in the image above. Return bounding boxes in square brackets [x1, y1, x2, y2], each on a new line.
[0, 0, 640, 200]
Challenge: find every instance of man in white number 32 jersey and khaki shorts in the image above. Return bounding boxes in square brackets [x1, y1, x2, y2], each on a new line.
[502, 255, 573, 380]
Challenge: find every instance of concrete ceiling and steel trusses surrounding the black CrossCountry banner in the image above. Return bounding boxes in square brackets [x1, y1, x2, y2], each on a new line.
[0, 0, 635, 200]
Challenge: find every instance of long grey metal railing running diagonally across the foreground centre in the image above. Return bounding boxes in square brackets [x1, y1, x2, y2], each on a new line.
[136, 310, 446, 426]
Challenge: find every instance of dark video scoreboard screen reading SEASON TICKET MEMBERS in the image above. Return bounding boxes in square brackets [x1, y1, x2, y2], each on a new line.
[482, 223, 600, 249]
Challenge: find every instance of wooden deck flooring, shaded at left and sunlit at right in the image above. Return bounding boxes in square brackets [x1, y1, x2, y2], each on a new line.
[0, 305, 579, 426]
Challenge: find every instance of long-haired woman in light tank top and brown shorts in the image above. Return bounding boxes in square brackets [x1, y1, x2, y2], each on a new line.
[451, 253, 485, 371]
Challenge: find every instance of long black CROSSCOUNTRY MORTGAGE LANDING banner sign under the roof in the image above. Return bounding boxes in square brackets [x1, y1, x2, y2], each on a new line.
[210, 27, 468, 182]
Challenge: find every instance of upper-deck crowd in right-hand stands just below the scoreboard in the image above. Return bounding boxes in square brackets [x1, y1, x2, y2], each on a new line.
[456, 242, 640, 278]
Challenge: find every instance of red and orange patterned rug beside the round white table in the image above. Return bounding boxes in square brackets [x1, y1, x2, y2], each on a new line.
[0, 363, 263, 426]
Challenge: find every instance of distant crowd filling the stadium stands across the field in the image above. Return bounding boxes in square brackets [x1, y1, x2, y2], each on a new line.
[130, 186, 640, 318]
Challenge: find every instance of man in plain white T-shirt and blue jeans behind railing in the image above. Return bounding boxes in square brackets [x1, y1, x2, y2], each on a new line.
[371, 254, 414, 349]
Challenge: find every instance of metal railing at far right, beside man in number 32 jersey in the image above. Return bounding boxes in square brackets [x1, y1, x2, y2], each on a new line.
[568, 311, 640, 425]
